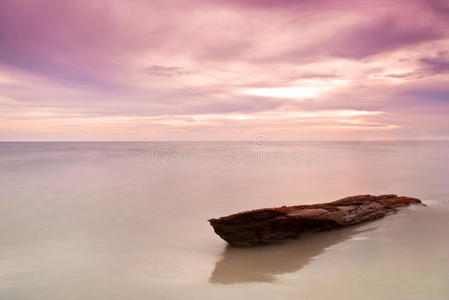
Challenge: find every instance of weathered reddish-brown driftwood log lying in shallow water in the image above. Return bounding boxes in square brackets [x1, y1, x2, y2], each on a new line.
[209, 195, 422, 246]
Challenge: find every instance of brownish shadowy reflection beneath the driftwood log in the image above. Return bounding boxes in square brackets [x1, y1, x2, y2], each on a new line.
[209, 226, 375, 284]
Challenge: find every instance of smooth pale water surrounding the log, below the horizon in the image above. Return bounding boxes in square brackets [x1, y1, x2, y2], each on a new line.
[0, 142, 449, 300]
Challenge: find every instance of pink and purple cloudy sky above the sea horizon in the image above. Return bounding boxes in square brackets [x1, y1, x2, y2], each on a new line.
[0, 0, 449, 141]
